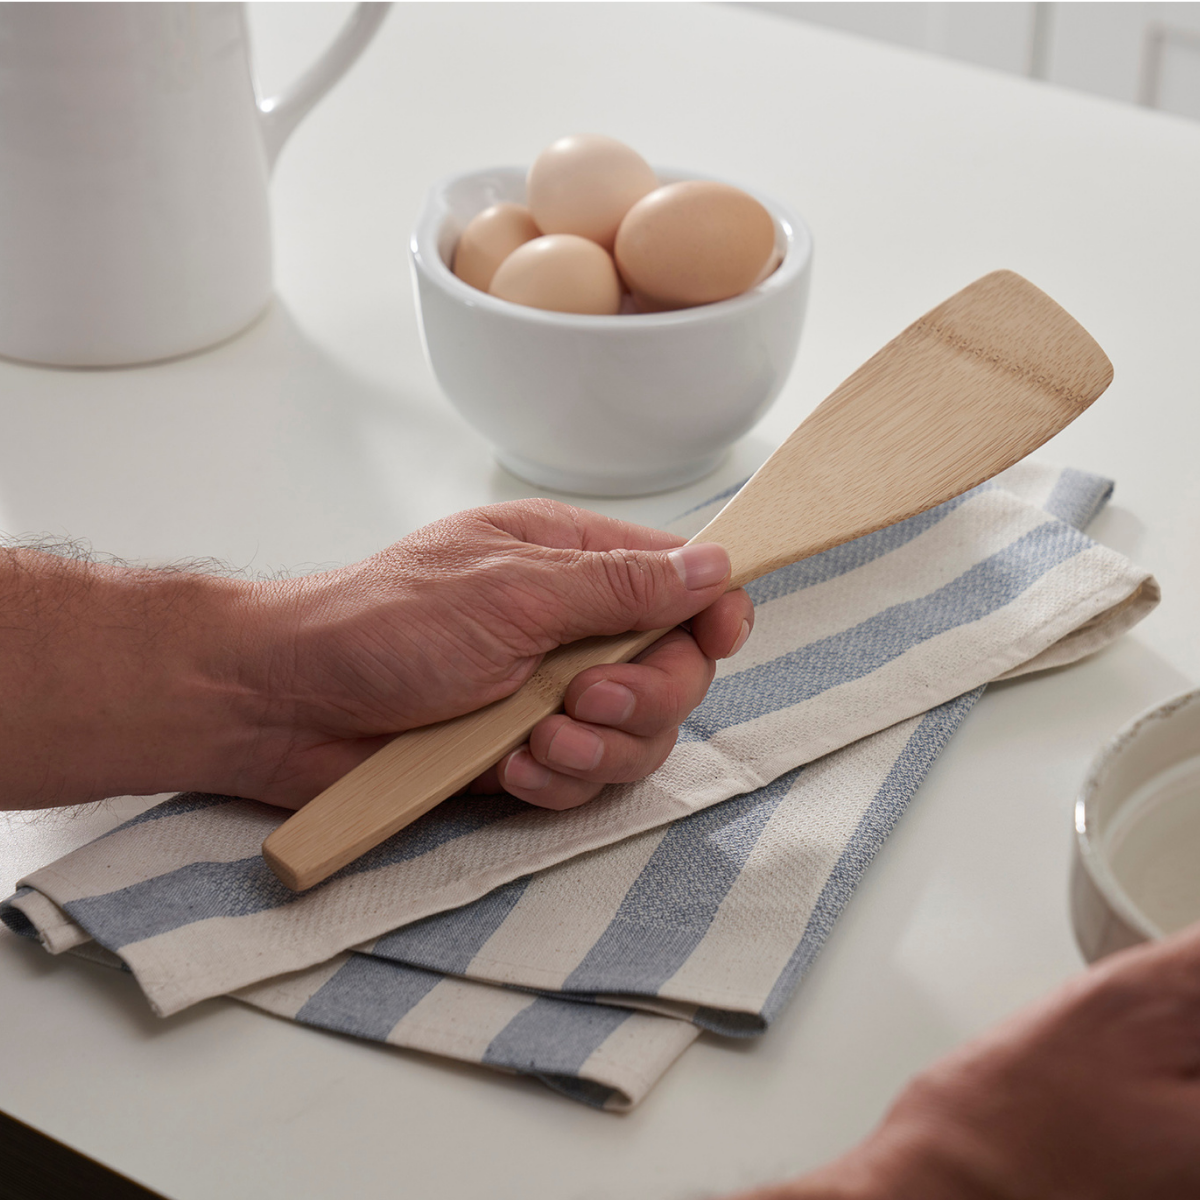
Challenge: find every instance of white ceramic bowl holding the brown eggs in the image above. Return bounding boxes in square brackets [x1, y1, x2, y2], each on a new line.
[410, 167, 812, 496]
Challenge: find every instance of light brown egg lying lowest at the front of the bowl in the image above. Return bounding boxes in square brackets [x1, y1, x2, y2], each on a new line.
[488, 233, 620, 316]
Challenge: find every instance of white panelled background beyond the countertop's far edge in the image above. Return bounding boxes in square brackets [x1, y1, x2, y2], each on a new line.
[755, 0, 1200, 120]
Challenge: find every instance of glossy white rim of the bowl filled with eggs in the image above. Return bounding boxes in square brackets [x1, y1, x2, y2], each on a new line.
[409, 164, 812, 332]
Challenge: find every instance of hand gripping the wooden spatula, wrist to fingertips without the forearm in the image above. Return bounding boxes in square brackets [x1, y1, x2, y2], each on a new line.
[242, 500, 754, 809]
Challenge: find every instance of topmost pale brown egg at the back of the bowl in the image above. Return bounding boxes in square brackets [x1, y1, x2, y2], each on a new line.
[526, 133, 659, 250]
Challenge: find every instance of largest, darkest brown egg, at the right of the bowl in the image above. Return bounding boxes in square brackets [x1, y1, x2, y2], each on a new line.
[616, 179, 775, 311]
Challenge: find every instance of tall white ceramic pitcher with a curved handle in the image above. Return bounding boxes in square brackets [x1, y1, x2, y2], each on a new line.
[0, 2, 389, 366]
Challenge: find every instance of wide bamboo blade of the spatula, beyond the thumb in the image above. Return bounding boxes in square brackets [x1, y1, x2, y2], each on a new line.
[696, 271, 1112, 587]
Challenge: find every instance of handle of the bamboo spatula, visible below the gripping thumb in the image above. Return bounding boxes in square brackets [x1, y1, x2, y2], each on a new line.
[263, 629, 666, 892]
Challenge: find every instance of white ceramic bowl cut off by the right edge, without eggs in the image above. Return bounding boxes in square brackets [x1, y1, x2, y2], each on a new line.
[1070, 691, 1200, 962]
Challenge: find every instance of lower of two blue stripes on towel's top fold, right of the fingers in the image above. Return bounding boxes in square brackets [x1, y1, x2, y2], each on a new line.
[679, 521, 1091, 742]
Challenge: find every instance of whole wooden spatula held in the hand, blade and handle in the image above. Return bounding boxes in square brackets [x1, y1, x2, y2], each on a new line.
[263, 271, 1112, 890]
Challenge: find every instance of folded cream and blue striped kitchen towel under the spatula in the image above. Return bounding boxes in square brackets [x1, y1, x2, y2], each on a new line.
[0, 463, 1158, 1109]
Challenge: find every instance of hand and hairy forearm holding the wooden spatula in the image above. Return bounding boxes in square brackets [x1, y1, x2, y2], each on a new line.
[0, 500, 754, 808]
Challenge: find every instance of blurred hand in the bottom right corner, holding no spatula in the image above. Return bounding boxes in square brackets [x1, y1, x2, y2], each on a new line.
[743, 924, 1200, 1200]
